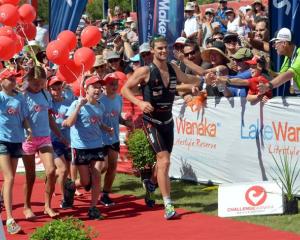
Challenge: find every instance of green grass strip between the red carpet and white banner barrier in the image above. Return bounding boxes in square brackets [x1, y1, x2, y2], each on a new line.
[113, 174, 300, 234]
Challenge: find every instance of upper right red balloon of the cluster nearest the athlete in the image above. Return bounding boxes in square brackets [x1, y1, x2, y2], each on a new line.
[81, 26, 102, 47]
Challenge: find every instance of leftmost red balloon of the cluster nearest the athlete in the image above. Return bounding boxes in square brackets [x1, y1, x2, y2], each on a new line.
[46, 40, 70, 65]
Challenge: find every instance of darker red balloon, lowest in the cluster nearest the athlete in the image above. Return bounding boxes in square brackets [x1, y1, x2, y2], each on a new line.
[56, 59, 82, 83]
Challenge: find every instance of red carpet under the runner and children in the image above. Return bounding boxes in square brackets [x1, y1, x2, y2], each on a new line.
[2, 175, 300, 240]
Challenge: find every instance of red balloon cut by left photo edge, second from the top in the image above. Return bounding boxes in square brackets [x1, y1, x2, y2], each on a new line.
[0, 4, 20, 27]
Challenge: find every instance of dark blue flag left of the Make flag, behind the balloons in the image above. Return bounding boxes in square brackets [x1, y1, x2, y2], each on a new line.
[49, 0, 87, 40]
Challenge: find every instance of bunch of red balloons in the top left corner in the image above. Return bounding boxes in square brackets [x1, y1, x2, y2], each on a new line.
[0, 0, 36, 61]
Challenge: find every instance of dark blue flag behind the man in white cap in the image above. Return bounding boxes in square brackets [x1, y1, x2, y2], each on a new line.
[269, 0, 300, 96]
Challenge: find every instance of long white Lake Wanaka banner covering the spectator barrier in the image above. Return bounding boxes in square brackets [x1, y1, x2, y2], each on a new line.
[170, 97, 300, 194]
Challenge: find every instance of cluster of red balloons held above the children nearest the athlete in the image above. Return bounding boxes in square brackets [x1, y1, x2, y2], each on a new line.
[46, 26, 102, 95]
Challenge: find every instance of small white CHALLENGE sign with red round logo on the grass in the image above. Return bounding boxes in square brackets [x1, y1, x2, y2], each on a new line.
[218, 182, 283, 217]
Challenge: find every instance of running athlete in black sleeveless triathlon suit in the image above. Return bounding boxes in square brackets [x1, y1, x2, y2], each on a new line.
[122, 36, 194, 220]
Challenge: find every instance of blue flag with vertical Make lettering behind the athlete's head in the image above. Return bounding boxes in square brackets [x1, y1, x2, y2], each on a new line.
[137, 0, 184, 56]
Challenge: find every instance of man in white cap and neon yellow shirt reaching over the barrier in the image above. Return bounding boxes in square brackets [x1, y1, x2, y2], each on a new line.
[259, 28, 300, 96]
